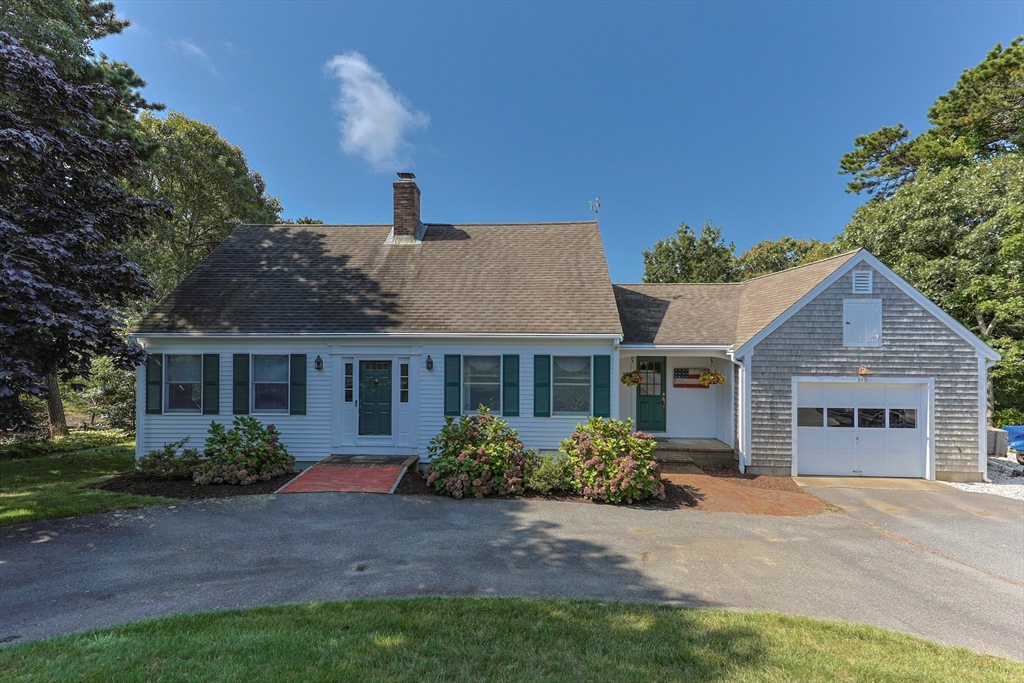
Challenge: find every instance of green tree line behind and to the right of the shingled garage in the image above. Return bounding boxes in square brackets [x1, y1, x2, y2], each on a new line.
[643, 37, 1024, 425]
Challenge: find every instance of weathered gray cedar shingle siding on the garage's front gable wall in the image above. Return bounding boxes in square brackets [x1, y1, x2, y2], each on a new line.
[751, 266, 978, 472]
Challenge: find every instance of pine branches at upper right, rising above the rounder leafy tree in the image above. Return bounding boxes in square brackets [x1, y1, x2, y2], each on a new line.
[840, 37, 1024, 199]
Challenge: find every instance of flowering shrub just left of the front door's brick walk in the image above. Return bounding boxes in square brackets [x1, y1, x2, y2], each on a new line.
[193, 416, 295, 485]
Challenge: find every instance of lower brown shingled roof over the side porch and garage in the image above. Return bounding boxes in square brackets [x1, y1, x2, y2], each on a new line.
[614, 251, 857, 348]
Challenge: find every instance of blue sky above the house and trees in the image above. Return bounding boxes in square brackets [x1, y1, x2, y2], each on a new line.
[96, 0, 1024, 283]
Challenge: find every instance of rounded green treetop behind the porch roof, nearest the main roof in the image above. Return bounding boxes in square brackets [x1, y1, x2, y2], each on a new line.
[643, 220, 739, 283]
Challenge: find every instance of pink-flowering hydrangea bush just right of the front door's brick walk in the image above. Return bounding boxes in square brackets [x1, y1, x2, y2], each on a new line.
[425, 409, 526, 498]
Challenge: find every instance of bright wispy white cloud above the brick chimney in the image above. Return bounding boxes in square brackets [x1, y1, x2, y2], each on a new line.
[324, 52, 430, 171]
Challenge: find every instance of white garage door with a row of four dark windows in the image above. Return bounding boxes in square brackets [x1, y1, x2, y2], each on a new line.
[796, 382, 928, 477]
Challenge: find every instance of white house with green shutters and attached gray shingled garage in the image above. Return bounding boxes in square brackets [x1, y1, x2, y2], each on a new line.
[132, 174, 998, 480]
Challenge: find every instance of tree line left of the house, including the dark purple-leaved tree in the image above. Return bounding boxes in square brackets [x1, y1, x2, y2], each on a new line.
[0, 0, 309, 435]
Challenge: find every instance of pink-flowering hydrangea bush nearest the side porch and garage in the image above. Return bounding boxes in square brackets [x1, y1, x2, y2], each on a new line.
[559, 418, 665, 503]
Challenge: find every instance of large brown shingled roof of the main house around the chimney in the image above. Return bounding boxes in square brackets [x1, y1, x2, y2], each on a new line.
[133, 222, 622, 335]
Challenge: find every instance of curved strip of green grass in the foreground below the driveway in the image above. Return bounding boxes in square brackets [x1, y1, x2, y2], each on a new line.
[0, 598, 1024, 683]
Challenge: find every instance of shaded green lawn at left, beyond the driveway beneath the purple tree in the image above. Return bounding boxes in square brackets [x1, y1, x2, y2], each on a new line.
[0, 445, 173, 526]
